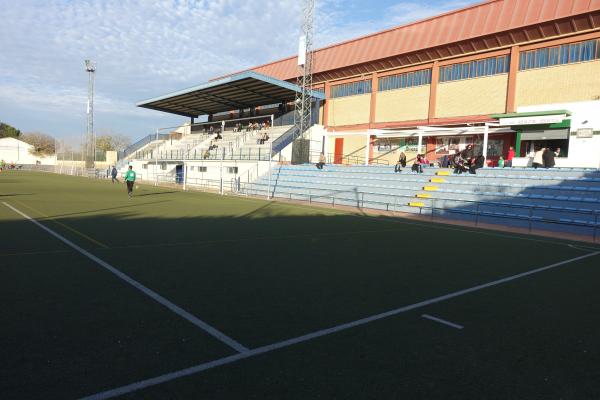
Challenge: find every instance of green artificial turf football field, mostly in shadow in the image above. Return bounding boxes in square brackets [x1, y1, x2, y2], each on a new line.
[0, 171, 600, 400]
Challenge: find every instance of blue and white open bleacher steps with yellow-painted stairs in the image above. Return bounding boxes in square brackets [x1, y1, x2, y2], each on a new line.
[255, 164, 600, 236]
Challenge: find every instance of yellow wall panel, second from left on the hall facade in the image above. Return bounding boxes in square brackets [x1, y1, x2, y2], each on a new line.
[375, 85, 430, 122]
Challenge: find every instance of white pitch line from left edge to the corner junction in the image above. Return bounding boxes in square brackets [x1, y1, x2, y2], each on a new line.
[2, 202, 248, 353]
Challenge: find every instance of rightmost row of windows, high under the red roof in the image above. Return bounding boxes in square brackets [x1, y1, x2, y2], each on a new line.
[519, 40, 600, 71]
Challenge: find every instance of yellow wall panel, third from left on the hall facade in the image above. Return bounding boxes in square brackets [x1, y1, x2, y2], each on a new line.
[435, 74, 508, 118]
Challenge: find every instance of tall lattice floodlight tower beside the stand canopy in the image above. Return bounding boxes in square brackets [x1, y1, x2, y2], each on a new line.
[294, 0, 315, 161]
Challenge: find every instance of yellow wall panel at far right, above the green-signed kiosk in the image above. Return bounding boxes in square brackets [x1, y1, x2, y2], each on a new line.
[516, 61, 600, 106]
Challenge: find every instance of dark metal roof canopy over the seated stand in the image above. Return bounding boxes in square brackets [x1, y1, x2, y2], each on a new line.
[136, 71, 325, 118]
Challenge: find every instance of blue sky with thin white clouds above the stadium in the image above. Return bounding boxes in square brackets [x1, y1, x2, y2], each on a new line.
[0, 0, 478, 140]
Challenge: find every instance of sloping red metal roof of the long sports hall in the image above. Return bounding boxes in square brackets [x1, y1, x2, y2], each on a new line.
[238, 0, 600, 80]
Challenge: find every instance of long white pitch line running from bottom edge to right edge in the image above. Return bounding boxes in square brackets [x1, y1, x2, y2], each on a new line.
[80, 251, 600, 400]
